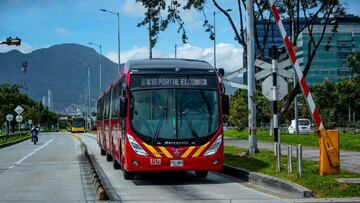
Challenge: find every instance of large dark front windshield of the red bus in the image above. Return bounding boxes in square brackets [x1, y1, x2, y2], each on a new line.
[130, 88, 220, 141]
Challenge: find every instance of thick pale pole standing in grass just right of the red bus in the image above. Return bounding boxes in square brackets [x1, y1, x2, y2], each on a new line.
[246, 0, 257, 155]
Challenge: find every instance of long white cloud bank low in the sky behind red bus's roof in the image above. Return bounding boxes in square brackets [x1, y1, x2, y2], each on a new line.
[105, 43, 243, 72]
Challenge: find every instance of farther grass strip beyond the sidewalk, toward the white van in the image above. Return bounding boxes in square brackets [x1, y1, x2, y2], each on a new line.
[224, 130, 360, 152]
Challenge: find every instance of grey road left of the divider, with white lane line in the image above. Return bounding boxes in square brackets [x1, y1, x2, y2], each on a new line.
[0, 133, 96, 202]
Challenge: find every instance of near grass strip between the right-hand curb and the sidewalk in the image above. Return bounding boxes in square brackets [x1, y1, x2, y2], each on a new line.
[225, 146, 360, 197]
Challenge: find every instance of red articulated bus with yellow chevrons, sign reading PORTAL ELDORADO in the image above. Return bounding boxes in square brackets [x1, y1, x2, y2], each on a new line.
[96, 59, 229, 179]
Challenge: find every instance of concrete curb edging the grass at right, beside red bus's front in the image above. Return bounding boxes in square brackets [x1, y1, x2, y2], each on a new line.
[221, 165, 314, 198]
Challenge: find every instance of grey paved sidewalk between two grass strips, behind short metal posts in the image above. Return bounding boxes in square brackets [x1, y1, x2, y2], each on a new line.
[225, 137, 360, 173]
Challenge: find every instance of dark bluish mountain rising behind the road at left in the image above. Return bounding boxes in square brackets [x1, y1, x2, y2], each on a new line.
[0, 44, 117, 112]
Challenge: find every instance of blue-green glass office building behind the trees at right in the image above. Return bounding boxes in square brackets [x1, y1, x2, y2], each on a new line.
[297, 16, 360, 86]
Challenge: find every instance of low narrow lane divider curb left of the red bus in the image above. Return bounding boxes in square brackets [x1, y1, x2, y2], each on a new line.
[80, 139, 121, 201]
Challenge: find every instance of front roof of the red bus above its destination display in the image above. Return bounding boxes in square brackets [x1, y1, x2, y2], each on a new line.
[127, 58, 214, 70]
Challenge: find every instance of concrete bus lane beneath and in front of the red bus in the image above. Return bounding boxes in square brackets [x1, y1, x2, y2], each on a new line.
[79, 134, 286, 202]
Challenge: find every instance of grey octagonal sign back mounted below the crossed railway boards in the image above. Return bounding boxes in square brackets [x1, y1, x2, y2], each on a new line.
[261, 75, 288, 101]
